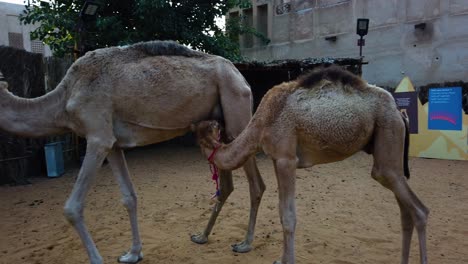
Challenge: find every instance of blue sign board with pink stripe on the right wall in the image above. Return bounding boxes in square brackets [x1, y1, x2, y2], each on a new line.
[428, 87, 462, 130]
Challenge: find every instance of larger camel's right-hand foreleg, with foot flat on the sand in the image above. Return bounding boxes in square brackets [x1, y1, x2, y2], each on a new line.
[107, 148, 143, 263]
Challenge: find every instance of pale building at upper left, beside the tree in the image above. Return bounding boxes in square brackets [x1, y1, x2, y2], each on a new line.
[0, 2, 52, 56]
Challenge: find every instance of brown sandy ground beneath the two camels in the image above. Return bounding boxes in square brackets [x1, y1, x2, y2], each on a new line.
[0, 145, 468, 264]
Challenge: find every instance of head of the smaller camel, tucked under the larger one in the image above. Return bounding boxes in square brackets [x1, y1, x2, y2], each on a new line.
[190, 120, 221, 150]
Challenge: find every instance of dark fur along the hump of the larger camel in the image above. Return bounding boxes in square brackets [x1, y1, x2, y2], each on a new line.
[127, 40, 207, 57]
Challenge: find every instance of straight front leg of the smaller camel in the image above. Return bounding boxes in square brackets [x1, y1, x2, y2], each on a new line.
[274, 159, 296, 264]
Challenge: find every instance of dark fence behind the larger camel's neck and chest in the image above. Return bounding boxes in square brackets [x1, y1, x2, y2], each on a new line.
[0, 46, 73, 184]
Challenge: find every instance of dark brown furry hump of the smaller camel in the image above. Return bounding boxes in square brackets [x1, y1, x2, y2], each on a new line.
[298, 65, 367, 90]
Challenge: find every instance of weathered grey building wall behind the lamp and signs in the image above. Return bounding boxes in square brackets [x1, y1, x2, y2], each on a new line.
[232, 0, 468, 86]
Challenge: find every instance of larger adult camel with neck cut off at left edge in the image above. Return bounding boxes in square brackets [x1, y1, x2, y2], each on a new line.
[0, 41, 265, 264]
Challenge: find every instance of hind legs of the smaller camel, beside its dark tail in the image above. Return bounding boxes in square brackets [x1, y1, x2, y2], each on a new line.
[372, 122, 429, 264]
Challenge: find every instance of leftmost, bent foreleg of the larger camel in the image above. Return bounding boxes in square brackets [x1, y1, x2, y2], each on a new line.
[64, 136, 114, 264]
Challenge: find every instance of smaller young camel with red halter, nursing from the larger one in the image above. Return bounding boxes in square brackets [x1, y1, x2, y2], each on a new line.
[192, 66, 429, 264]
